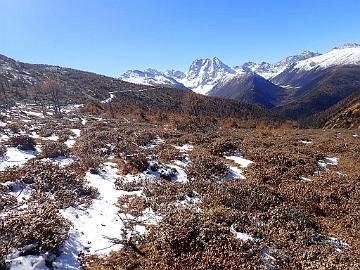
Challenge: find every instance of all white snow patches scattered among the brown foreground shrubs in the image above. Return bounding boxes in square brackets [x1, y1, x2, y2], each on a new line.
[0, 102, 349, 270]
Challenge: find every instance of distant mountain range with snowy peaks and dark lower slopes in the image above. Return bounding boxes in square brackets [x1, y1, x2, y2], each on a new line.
[120, 43, 360, 119]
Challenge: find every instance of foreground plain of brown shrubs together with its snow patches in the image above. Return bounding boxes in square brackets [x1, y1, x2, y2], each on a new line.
[0, 104, 360, 269]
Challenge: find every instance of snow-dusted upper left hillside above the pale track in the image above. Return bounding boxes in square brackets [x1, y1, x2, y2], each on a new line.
[0, 55, 157, 103]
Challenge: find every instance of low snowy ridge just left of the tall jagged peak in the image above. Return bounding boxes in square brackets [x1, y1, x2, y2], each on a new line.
[120, 68, 185, 88]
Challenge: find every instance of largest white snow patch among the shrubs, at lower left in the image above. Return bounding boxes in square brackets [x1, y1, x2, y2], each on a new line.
[54, 162, 159, 269]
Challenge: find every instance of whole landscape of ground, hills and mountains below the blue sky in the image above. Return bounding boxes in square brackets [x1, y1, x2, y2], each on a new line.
[0, 45, 360, 270]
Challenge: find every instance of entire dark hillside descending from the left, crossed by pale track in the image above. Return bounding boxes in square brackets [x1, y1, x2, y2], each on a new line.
[0, 53, 277, 125]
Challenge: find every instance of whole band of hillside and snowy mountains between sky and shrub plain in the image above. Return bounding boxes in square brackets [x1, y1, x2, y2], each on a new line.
[0, 44, 360, 127]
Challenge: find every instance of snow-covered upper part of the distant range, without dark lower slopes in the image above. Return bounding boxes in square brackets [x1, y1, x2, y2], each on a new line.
[120, 44, 360, 95]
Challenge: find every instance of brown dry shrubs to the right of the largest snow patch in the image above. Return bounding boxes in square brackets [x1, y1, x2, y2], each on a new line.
[74, 123, 360, 269]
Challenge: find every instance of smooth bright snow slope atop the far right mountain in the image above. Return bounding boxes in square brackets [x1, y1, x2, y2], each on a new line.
[294, 44, 360, 71]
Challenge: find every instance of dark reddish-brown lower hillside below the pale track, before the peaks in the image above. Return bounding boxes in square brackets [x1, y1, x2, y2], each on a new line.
[81, 87, 282, 123]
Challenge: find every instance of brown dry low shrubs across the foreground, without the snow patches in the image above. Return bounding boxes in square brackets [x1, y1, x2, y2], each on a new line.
[0, 113, 360, 269]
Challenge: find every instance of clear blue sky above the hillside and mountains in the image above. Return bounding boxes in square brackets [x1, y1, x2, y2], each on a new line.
[0, 0, 360, 76]
